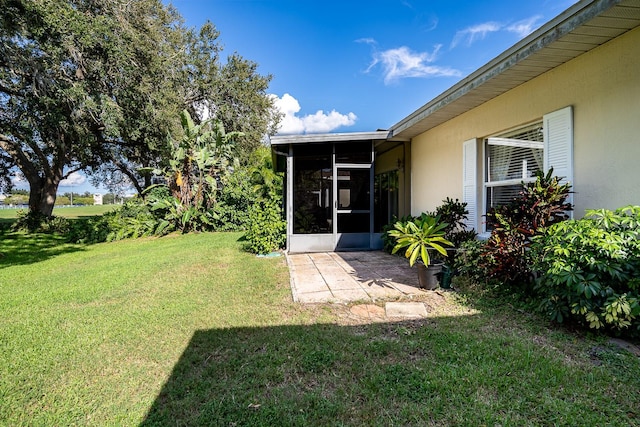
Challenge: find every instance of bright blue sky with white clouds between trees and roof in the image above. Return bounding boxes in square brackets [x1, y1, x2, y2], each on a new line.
[15, 0, 575, 193]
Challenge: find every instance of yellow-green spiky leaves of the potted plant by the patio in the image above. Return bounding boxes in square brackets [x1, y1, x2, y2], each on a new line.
[388, 214, 453, 267]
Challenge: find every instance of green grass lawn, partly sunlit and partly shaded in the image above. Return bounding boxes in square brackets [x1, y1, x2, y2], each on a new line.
[0, 233, 640, 426]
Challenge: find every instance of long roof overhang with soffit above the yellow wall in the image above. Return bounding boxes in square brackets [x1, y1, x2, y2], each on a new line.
[390, 0, 640, 140]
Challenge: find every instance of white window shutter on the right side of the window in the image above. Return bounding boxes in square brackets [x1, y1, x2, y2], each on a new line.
[542, 106, 573, 207]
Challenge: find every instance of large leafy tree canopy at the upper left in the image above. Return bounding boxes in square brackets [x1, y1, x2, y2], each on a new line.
[0, 0, 280, 215]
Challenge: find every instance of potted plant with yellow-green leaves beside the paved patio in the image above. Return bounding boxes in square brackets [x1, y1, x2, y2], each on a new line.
[388, 214, 453, 289]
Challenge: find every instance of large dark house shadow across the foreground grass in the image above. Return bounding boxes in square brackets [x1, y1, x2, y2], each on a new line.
[140, 313, 634, 427]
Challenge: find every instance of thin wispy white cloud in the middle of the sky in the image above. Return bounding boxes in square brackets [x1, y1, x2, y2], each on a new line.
[366, 45, 462, 84]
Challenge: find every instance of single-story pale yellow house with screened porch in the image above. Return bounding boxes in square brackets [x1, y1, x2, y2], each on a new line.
[271, 0, 640, 252]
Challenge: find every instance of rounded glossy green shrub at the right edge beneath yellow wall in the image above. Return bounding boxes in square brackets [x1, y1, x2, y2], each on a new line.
[532, 206, 640, 335]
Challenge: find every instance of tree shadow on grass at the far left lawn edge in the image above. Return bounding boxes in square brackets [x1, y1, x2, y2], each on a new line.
[0, 232, 84, 268]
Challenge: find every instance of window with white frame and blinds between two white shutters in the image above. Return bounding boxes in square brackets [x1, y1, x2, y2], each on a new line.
[484, 122, 544, 213]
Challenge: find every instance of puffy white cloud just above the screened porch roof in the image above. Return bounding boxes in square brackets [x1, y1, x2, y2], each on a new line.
[272, 93, 358, 135]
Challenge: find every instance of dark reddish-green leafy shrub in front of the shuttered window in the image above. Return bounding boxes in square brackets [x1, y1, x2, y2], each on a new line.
[484, 169, 572, 291]
